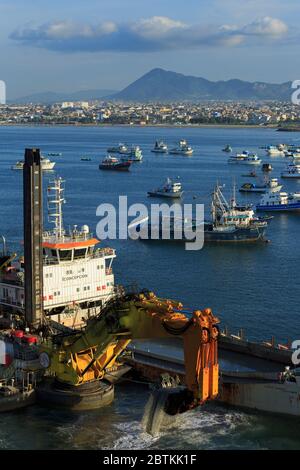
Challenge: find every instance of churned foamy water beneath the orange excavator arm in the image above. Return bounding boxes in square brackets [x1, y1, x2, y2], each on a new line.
[106, 403, 260, 450]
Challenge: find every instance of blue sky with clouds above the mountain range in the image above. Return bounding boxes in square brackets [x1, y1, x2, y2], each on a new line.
[0, 0, 300, 99]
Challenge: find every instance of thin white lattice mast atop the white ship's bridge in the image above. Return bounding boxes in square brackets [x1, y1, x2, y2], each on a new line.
[48, 177, 65, 238]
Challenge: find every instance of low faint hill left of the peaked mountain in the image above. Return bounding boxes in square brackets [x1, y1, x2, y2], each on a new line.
[9, 90, 116, 104]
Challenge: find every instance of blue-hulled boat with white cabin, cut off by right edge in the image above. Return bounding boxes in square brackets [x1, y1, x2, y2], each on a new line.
[256, 192, 300, 212]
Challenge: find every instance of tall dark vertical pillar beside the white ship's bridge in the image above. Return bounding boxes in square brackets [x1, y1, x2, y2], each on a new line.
[23, 148, 43, 327]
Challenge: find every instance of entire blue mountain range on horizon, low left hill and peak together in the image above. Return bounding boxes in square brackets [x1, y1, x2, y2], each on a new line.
[10, 68, 292, 104]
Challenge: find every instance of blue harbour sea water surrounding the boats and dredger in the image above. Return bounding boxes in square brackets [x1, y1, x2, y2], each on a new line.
[0, 127, 300, 449]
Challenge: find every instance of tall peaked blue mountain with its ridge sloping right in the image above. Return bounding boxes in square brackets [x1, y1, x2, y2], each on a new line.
[113, 68, 291, 102]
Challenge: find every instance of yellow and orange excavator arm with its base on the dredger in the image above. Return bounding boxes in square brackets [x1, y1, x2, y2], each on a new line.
[41, 292, 219, 414]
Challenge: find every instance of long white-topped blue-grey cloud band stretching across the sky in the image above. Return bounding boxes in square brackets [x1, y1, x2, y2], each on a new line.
[11, 16, 288, 52]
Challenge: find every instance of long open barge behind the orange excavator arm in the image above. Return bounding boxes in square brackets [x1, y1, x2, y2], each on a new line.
[126, 332, 300, 417]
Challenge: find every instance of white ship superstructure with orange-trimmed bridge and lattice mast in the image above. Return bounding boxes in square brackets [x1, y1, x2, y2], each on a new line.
[0, 178, 116, 327]
